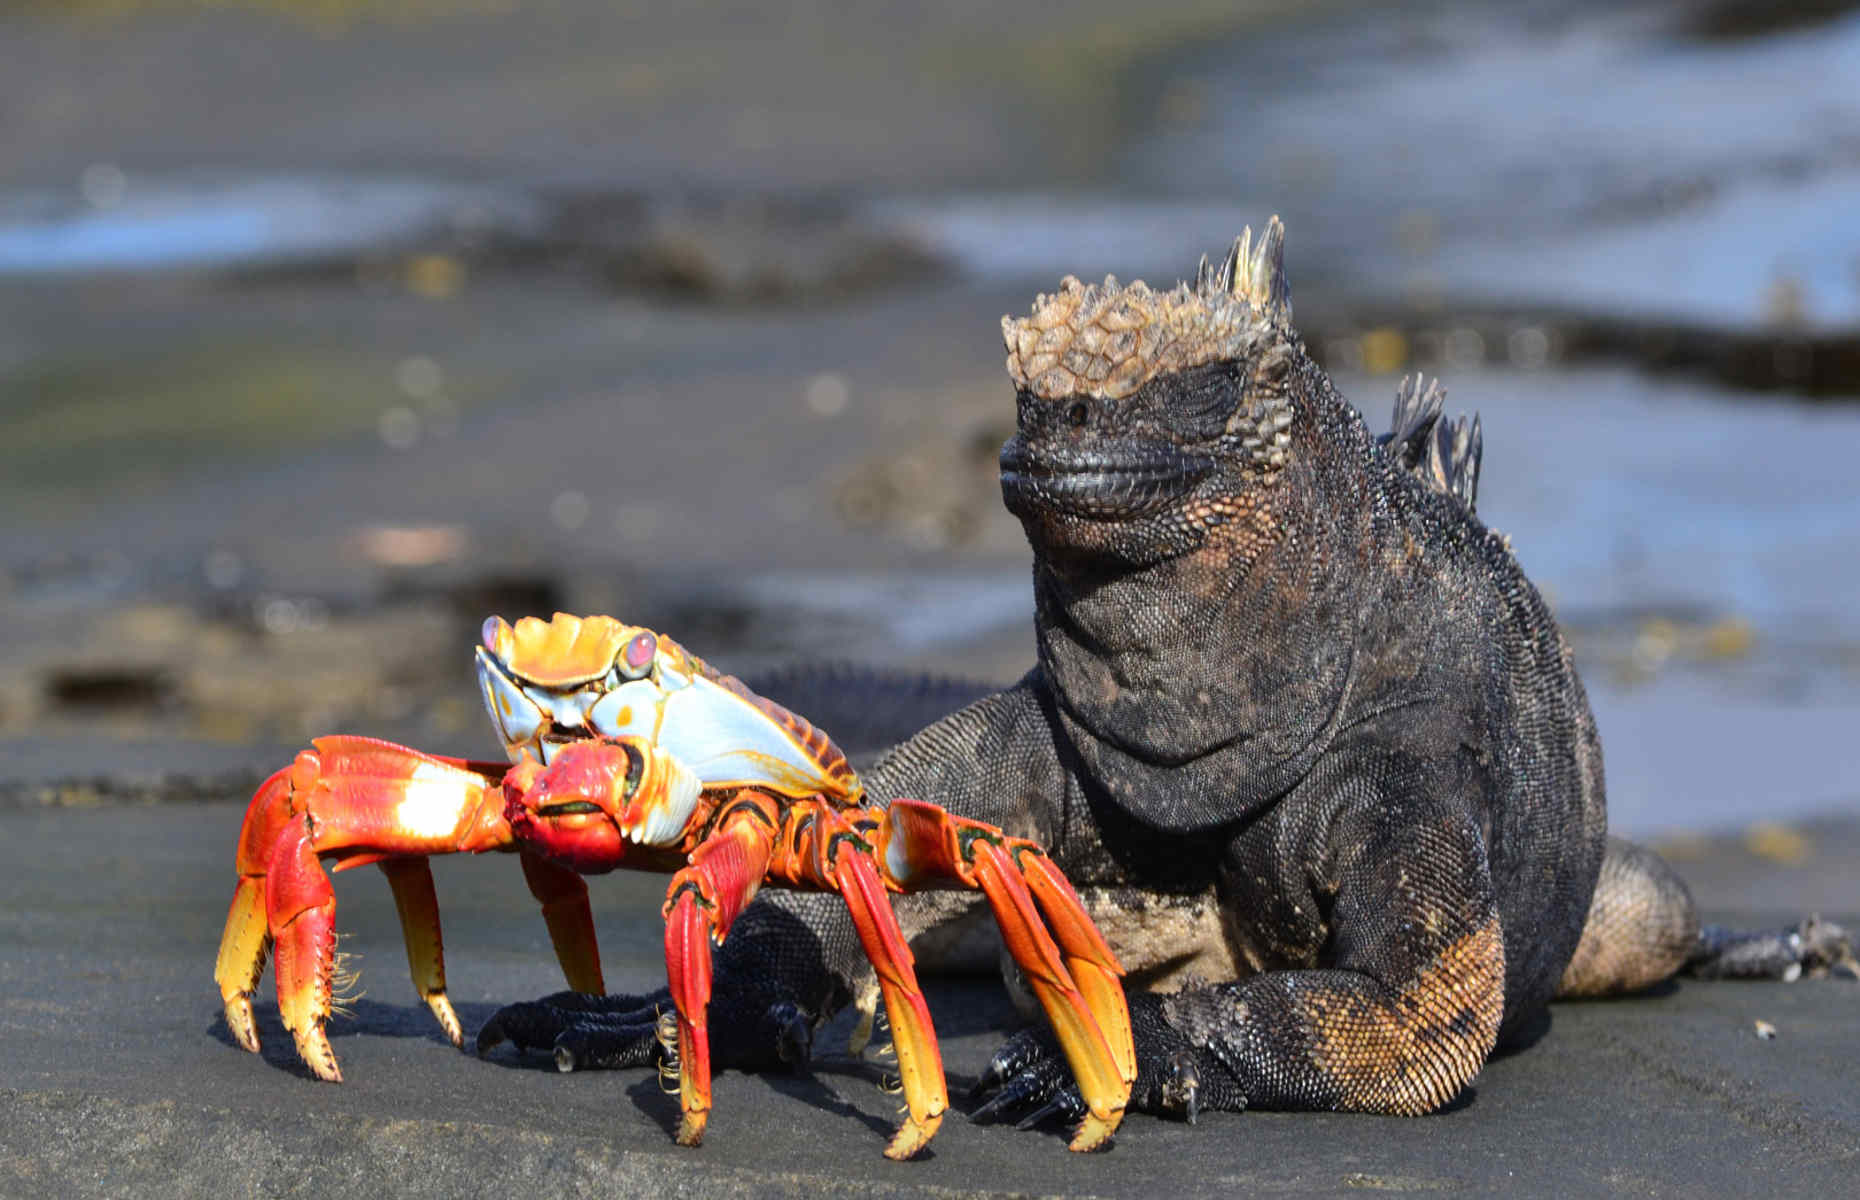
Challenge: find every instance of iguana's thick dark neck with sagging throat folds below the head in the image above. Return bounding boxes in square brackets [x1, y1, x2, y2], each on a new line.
[1034, 388, 1373, 830]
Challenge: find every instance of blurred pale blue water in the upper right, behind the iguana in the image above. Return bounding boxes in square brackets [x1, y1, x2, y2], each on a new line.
[1122, 6, 1860, 324]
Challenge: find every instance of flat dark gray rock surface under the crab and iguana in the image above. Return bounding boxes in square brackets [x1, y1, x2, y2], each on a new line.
[0, 802, 1860, 1196]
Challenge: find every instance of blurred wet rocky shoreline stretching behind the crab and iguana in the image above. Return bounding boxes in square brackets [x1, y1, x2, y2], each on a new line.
[0, 0, 1860, 840]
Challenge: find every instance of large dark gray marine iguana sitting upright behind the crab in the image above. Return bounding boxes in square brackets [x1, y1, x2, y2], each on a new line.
[478, 218, 1851, 1124]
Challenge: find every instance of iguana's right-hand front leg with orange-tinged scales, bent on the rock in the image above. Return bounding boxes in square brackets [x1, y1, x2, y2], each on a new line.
[982, 753, 1505, 1120]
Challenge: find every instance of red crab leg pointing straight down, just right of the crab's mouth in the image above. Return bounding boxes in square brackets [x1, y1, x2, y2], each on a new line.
[664, 793, 777, 1146]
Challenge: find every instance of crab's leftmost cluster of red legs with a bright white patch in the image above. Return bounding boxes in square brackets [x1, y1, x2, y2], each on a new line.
[214, 737, 512, 1081]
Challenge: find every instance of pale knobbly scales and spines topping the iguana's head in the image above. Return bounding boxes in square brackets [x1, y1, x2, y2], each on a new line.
[1001, 216, 1291, 400]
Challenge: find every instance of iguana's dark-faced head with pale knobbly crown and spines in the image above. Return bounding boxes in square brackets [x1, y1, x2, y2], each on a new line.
[1001, 218, 1296, 562]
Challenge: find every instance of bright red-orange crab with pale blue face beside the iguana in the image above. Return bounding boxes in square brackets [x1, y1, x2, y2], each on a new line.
[216, 614, 1136, 1159]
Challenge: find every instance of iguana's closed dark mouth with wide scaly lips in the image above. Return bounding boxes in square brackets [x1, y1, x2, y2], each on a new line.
[1001, 437, 1215, 521]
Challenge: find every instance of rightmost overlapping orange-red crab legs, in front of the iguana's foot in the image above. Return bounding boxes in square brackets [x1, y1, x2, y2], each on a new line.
[874, 800, 1136, 1150]
